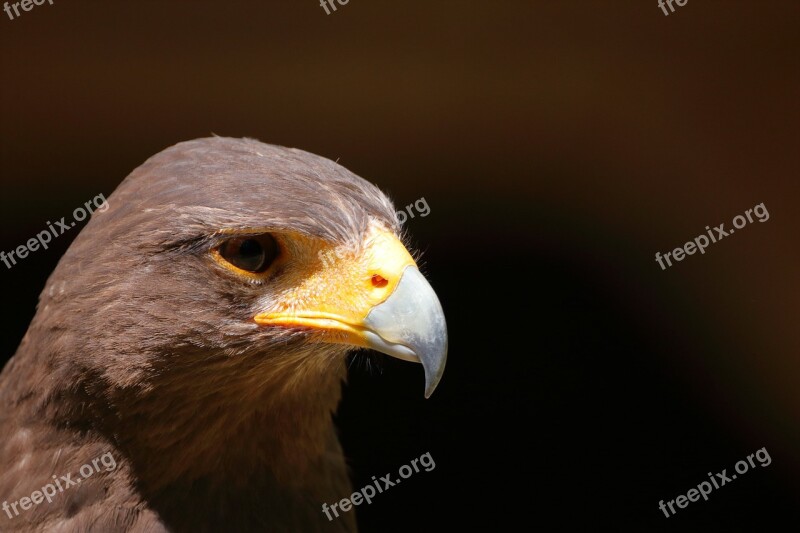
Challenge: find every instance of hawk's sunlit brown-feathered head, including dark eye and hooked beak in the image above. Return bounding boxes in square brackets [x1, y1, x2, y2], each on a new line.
[50, 139, 447, 396]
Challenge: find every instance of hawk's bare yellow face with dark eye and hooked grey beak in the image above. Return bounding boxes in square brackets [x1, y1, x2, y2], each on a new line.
[206, 220, 447, 396]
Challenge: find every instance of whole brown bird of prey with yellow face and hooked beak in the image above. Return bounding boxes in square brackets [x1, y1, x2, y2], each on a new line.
[0, 137, 447, 533]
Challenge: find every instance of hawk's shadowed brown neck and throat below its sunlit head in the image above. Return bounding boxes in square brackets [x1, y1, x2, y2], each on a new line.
[0, 336, 352, 531]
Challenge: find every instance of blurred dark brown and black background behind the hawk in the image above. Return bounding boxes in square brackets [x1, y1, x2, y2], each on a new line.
[0, 0, 800, 532]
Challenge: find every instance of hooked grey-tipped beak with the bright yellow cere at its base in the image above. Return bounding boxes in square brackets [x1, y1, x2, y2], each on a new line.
[254, 228, 447, 398]
